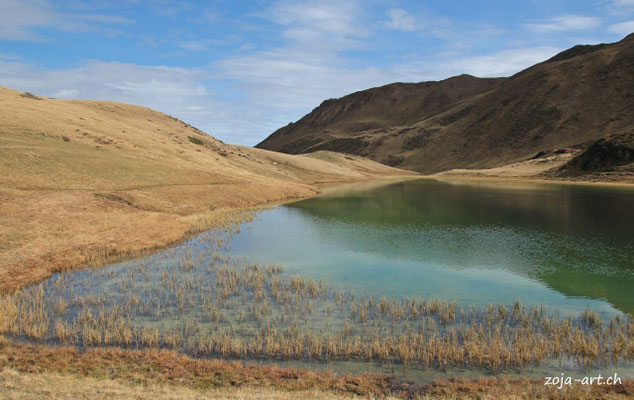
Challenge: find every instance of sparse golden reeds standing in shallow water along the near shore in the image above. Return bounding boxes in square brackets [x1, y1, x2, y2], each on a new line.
[0, 216, 634, 371]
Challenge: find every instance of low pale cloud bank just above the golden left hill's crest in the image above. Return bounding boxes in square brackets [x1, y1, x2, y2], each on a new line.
[0, 61, 221, 130]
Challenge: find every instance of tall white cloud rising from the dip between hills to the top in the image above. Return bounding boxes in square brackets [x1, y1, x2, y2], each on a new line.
[198, 0, 394, 144]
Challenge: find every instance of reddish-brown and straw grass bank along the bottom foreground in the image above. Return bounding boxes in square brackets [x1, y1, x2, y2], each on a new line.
[0, 344, 634, 400]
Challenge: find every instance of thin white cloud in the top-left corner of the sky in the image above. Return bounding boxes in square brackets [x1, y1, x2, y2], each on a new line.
[0, 0, 130, 41]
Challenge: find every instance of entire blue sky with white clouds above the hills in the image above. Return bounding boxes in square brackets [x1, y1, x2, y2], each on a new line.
[0, 0, 634, 145]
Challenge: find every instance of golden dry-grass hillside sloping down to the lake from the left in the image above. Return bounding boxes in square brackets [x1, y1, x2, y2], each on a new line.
[0, 88, 405, 292]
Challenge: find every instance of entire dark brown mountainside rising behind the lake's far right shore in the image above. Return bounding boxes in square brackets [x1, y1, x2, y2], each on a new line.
[257, 34, 634, 177]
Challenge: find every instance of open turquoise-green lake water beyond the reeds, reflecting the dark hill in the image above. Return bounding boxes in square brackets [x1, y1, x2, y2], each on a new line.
[231, 179, 634, 314]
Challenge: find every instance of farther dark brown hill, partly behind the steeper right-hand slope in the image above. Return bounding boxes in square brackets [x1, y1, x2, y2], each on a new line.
[256, 75, 502, 155]
